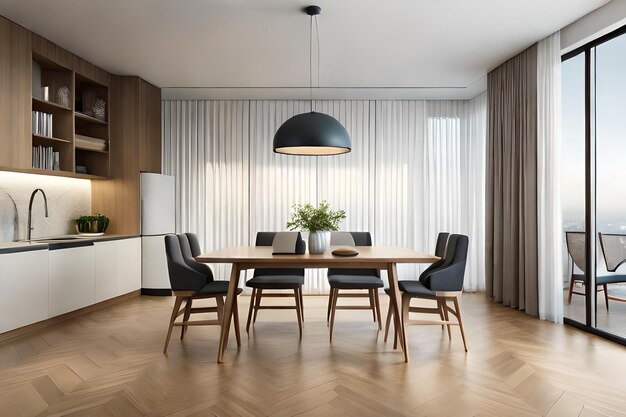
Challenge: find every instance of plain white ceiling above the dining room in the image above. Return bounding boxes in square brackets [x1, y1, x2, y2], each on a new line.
[0, 0, 608, 97]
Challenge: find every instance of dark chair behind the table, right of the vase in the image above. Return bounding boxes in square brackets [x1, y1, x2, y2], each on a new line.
[326, 232, 384, 342]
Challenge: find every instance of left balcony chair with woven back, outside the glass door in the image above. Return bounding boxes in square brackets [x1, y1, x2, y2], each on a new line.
[565, 232, 611, 311]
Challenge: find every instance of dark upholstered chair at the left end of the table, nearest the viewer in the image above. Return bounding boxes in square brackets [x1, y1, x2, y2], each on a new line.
[163, 234, 242, 353]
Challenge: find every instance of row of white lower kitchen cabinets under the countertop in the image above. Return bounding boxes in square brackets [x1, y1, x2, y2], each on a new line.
[0, 237, 141, 333]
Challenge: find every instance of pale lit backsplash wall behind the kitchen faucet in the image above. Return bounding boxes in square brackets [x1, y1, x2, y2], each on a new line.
[0, 171, 91, 241]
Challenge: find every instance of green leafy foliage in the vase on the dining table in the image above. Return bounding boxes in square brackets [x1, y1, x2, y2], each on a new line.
[287, 200, 346, 232]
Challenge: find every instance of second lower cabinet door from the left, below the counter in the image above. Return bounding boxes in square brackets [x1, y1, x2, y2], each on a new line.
[49, 245, 96, 317]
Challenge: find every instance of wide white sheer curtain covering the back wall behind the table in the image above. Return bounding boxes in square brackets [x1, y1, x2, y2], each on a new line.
[163, 94, 486, 293]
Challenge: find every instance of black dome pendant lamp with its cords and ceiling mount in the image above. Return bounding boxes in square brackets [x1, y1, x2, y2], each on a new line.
[274, 6, 352, 156]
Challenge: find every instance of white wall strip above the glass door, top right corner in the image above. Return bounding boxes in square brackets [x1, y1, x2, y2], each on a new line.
[561, 0, 626, 53]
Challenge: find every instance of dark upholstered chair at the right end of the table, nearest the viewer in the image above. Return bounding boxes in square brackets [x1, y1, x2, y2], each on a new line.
[382, 234, 469, 352]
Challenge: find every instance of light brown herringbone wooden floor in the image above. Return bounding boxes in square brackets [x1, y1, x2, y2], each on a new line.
[0, 294, 626, 417]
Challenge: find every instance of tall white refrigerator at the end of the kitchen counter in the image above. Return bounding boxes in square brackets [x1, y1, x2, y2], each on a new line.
[140, 172, 176, 295]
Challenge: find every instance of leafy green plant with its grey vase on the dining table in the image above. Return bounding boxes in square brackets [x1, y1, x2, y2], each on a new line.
[287, 200, 346, 253]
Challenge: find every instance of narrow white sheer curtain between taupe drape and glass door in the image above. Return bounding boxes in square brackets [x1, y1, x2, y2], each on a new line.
[537, 32, 563, 323]
